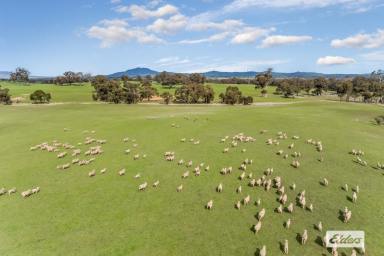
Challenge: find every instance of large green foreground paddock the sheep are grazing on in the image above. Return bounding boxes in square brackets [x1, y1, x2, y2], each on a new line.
[0, 97, 384, 256]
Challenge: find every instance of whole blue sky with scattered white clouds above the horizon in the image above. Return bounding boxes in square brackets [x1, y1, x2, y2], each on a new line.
[0, 0, 384, 75]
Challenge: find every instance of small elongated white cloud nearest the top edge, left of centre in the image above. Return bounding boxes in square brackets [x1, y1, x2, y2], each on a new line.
[115, 4, 179, 20]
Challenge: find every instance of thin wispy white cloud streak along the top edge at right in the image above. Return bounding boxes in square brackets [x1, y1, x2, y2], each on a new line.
[224, 0, 372, 12]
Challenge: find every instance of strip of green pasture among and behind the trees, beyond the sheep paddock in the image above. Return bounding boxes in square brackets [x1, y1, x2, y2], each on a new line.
[0, 81, 324, 103]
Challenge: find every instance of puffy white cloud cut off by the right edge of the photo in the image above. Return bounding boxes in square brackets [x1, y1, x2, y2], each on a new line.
[331, 29, 384, 48]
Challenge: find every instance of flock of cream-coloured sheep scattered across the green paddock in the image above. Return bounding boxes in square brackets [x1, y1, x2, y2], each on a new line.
[0, 125, 374, 256]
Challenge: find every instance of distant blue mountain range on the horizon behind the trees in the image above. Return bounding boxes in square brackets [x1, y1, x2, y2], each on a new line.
[108, 68, 367, 78]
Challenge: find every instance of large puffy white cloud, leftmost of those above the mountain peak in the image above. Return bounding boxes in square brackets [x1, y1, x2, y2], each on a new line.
[87, 19, 164, 48]
